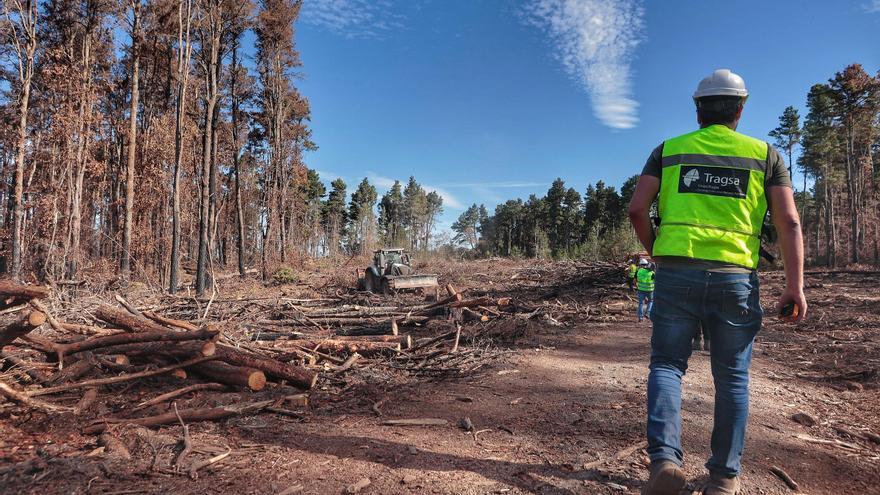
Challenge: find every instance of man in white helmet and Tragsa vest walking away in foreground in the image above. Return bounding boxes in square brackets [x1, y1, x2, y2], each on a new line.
[629, 69, 807, 495]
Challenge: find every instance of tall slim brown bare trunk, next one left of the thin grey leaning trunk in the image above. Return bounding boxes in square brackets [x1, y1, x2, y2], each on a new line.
[119, 0, 141, 279]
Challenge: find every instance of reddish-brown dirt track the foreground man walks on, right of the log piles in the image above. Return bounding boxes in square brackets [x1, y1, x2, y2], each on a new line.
[223, 321, 880, 494]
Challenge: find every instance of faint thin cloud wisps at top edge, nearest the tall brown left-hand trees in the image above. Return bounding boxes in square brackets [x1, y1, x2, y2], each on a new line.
[300, 0, 405, 38]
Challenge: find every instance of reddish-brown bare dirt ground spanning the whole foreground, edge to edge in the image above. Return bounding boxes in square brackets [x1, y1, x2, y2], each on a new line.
[0, 270, 880, 495]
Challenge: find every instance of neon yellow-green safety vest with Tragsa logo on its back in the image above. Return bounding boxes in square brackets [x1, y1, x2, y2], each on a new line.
[653, 125, 768, 268]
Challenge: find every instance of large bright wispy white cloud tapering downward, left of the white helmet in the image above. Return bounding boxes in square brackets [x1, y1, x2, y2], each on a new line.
[525, 0, 644, 129]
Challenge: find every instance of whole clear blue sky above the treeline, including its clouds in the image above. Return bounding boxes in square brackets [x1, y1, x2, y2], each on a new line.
[297, 0, 880, 232]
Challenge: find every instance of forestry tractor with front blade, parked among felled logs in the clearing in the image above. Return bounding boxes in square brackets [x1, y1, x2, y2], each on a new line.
[358, 248, 437, 294]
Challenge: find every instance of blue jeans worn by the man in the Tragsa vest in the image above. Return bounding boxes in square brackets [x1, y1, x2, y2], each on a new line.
[648, 267, 764, 476]
